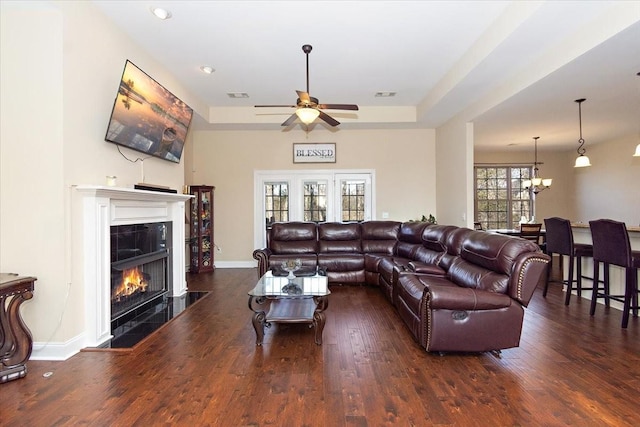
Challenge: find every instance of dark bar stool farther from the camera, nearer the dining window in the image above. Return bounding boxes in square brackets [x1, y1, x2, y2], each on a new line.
[542, 217, 595, 305]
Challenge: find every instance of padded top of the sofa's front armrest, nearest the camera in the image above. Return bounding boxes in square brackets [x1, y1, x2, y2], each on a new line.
[425, 283, 513, 311]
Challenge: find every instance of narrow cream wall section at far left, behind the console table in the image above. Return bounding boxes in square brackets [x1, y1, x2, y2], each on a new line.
[0, 5, 67, 350]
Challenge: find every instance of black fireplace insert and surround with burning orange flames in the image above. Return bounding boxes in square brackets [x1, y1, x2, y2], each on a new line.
[111, 222, 171, 328]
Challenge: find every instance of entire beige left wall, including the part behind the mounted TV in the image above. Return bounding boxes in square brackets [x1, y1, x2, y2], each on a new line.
[0, 1, 202, 358]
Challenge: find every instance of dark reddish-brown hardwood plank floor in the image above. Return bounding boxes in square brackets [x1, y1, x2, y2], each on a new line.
[5, 269, 640, 427]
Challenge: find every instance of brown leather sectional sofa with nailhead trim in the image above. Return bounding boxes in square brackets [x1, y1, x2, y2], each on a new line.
[253, 221, 549, 352]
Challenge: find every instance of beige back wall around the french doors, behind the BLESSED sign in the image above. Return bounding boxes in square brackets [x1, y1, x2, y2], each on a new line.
[186, 126, 436, 265]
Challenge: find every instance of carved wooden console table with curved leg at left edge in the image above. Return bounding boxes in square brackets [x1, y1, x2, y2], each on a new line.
[0, 273, 37, 383]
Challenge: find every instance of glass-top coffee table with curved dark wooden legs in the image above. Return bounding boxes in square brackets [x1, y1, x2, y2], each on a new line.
[249, 271, 331, 345]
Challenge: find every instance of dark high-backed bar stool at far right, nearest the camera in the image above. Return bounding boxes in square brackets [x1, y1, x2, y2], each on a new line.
[589, 219, 640, 328]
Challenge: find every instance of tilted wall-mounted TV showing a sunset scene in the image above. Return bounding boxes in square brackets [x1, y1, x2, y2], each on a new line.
[105, 60, 193, 163]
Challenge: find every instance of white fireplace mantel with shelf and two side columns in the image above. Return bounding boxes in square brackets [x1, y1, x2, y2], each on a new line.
[75, 185, 193, 347]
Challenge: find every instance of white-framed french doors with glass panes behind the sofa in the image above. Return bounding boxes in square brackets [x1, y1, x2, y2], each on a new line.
[254, 170, 375, 248]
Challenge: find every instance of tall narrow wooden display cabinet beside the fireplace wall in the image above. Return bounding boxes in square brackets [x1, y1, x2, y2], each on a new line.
[189, 185, 215, 273]
